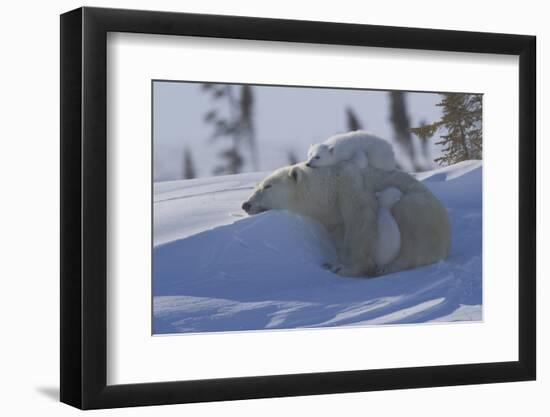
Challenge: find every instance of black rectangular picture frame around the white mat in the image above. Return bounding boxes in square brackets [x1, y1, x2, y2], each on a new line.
[60, 7, 536, 409]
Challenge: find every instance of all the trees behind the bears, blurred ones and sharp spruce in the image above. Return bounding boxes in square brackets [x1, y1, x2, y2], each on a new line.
[182, 83, 482, 179]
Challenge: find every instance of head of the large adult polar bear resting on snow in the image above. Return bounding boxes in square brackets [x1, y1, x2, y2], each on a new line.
[242, 163, 307, 214]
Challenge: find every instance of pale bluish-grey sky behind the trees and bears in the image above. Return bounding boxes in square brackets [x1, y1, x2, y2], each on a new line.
[153, 81, 441, 181]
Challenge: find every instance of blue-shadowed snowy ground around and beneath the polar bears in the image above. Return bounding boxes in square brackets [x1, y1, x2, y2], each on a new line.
[153, 161, 482, 334]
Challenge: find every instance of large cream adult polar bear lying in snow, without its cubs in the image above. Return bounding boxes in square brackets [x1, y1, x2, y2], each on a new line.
[242, 162, 451, 276]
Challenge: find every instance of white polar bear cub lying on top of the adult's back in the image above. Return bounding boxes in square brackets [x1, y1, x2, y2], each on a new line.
[307, 130, 395, 171]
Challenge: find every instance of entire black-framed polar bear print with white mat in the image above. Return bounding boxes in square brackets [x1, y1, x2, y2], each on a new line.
[61, 8, 536, 409]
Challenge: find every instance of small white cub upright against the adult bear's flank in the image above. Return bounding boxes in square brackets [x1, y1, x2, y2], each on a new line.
[374, 187, 403, 271]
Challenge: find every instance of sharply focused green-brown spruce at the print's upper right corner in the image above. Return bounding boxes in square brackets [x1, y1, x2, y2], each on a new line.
[410, 93, 483, 165]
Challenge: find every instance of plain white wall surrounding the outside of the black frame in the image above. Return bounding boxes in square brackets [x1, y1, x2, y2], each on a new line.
[0, 0, 550, 417]
